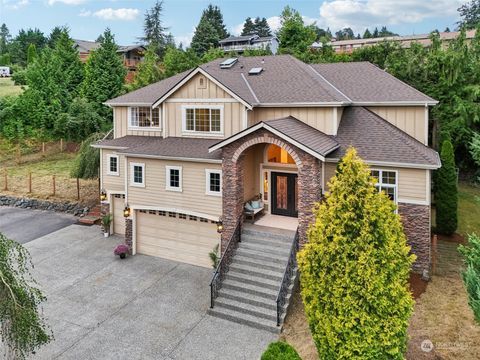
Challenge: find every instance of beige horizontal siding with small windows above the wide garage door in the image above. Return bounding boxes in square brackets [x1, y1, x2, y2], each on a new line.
[128, 158, 222, 217]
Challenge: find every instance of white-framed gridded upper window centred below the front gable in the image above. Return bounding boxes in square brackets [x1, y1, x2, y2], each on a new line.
[183, 106, 223, 134]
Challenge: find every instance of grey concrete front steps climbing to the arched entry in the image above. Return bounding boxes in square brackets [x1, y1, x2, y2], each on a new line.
[208, 224, 296, 333]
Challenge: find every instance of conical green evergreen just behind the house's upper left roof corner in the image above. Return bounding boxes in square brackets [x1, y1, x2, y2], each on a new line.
[81, 29, 126, 119]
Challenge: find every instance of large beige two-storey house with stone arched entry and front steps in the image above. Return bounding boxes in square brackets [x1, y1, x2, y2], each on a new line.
[94, 55, 440, 330]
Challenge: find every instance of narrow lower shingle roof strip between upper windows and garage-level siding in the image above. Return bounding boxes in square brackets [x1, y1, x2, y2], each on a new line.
[96, 135, 221, 160]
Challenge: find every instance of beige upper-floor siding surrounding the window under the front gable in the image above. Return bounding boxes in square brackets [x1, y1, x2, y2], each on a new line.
[165, 102, 245, 139]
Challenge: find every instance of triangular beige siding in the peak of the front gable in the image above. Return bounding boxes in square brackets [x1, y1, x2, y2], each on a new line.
[169, 74, 232, 99]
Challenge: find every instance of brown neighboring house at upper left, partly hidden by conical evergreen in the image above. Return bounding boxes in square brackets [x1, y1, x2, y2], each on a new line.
[73, 40, 146, 82]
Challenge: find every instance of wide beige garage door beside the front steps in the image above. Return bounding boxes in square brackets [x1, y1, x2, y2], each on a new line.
[136, 211, 220, 267]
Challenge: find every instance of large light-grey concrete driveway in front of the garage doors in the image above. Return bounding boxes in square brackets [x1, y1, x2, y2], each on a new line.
[26, 225, 276, 359]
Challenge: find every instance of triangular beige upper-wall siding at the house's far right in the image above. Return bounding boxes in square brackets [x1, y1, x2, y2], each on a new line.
[369, 106, 428, 144]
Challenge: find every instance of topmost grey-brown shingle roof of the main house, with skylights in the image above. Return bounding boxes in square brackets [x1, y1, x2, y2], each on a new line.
[107, 55, 434, 106]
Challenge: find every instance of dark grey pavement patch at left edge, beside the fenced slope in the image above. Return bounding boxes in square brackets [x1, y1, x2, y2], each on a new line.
[0, 206, 78, 244]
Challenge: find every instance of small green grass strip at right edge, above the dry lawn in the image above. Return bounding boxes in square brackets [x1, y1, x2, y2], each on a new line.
[457, 183, 480, 236]
